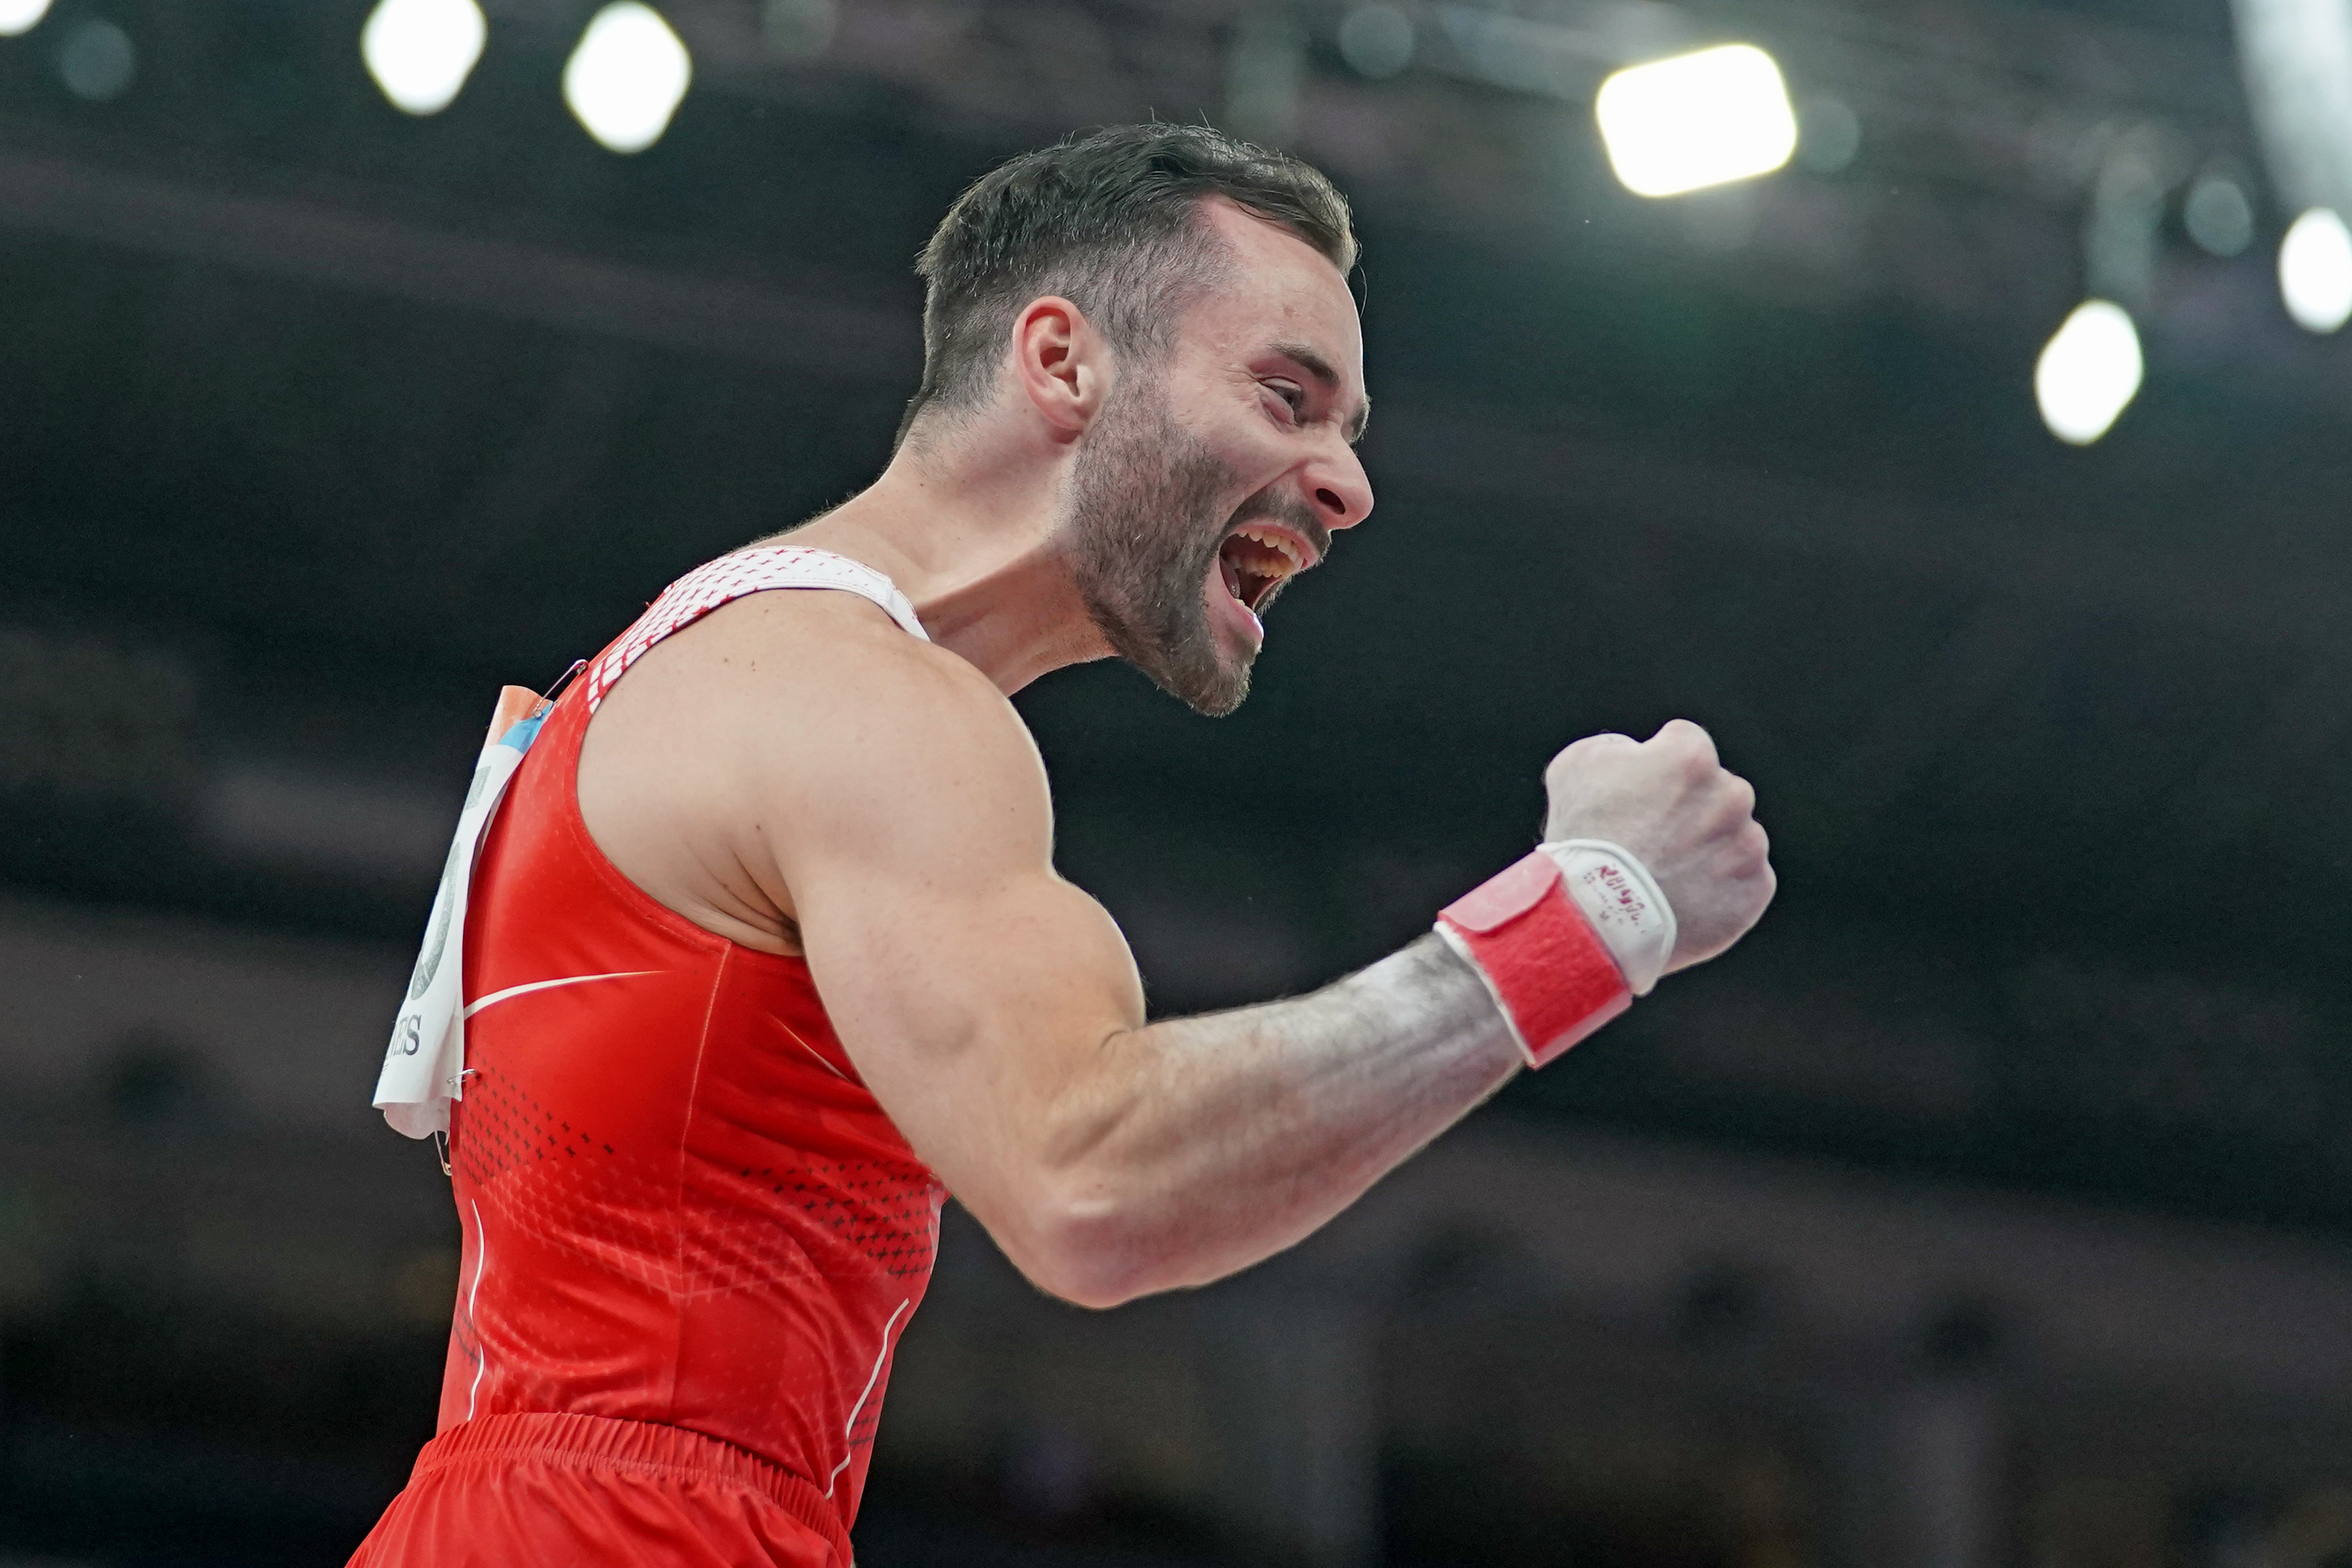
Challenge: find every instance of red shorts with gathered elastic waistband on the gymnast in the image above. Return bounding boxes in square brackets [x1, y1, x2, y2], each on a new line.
[350, 1413, 849, 1568]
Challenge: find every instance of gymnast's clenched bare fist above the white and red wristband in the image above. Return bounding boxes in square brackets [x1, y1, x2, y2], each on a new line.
[1543, 719, 1773, 973]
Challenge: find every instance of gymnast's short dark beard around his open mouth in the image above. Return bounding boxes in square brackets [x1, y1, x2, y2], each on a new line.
[1063, 381, 1312, 719]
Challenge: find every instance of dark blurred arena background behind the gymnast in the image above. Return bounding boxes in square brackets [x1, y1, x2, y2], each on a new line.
[0, 0, 2352, 1568]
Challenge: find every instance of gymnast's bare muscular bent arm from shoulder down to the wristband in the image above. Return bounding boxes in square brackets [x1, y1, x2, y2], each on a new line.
[746, 606, 1762, 1305]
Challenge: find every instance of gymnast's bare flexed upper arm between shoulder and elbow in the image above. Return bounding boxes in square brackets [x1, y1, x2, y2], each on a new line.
[762, 625, 1143, 1276]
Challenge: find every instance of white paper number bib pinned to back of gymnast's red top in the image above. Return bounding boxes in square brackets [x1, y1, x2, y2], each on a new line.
[376, 686, 546, 1138]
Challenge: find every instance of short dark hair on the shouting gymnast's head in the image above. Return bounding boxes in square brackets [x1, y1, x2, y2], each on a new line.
[898, 122, 1355, 439]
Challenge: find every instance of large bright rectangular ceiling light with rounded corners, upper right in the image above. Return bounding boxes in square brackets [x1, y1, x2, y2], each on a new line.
[1592, 45, 1797, 195]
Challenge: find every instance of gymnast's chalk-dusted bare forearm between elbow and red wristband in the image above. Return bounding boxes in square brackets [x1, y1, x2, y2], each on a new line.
[1044, 938, 1522, 1300]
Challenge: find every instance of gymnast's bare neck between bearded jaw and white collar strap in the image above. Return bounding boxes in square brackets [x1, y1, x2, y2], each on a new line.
[767, 416, 1110, 696]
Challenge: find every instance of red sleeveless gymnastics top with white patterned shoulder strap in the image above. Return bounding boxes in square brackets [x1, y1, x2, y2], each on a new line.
[440, 550, 946, 1530]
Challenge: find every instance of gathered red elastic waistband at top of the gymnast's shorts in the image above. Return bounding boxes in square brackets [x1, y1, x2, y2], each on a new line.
[412, 1410, 849, 1563]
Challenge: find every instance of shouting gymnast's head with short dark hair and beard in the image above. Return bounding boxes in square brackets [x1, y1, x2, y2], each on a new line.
[898, 125, 1371, 715]
